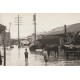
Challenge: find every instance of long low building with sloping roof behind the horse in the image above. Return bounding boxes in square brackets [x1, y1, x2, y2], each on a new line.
[36, 23, 80, 45]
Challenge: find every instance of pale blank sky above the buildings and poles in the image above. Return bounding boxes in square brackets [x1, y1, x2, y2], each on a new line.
[0, 13, 80, 38]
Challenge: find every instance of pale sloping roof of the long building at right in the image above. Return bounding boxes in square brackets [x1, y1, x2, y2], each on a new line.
[42, 23, 80, 35]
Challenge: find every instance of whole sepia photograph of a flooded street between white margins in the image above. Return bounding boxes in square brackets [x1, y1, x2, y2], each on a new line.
[0, 13, 80, 66]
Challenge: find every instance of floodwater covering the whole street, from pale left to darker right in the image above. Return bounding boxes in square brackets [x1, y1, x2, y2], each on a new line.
[1, 45, 80, 66]
